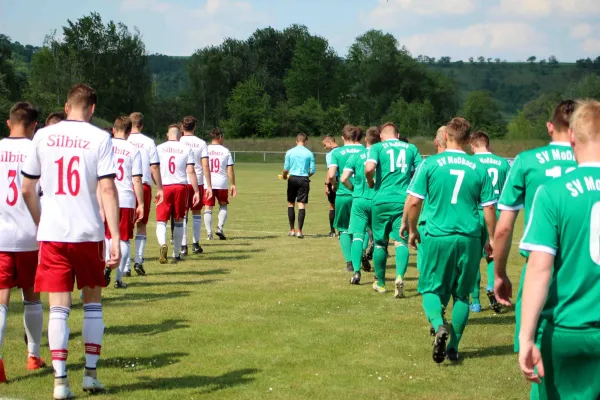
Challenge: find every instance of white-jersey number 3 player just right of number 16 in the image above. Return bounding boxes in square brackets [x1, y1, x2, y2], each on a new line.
[100, 116, 145, 289]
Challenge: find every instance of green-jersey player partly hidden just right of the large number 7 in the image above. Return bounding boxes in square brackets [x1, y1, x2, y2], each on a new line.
[471, 131, 510, 312]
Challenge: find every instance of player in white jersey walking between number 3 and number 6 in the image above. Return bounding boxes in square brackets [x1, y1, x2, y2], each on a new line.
[125, 112, 163, 276]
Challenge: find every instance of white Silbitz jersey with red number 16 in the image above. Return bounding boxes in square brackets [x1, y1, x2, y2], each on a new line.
[22, 120, 116, 243]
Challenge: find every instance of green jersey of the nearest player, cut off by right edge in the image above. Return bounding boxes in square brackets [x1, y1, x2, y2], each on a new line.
[520, 163, 600, 329]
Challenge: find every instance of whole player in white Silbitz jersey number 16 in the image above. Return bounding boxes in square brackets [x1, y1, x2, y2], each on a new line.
[21, 84, 121, 399]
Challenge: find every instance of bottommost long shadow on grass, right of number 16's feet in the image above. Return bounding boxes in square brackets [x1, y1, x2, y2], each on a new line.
[109, 368, 260, 394]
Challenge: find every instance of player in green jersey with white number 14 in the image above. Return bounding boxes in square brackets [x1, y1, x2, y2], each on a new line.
[365, 123, 423, 298]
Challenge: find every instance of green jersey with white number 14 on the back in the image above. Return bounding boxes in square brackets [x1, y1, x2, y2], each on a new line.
[367, 139, 423, 204]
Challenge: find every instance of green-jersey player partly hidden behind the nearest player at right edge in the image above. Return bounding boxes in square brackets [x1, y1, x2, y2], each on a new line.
[494, 100, 577, 352]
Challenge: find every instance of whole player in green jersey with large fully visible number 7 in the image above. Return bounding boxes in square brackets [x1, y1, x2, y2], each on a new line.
[401, 118, 497, 363]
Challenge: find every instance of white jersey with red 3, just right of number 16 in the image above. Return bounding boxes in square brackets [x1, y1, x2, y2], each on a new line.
[113, 138, 143, 208]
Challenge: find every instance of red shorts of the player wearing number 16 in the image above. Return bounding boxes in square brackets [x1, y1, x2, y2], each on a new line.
[35, 241, 106, 293]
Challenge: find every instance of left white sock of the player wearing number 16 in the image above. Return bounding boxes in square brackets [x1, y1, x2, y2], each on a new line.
[48, 306, 71, 378]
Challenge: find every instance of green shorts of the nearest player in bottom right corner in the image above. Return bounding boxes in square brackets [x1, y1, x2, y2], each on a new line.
[538, 323, 600, 400]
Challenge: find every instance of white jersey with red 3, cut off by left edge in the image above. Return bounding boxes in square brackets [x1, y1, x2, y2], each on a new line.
[0, 138, 38, 252]
